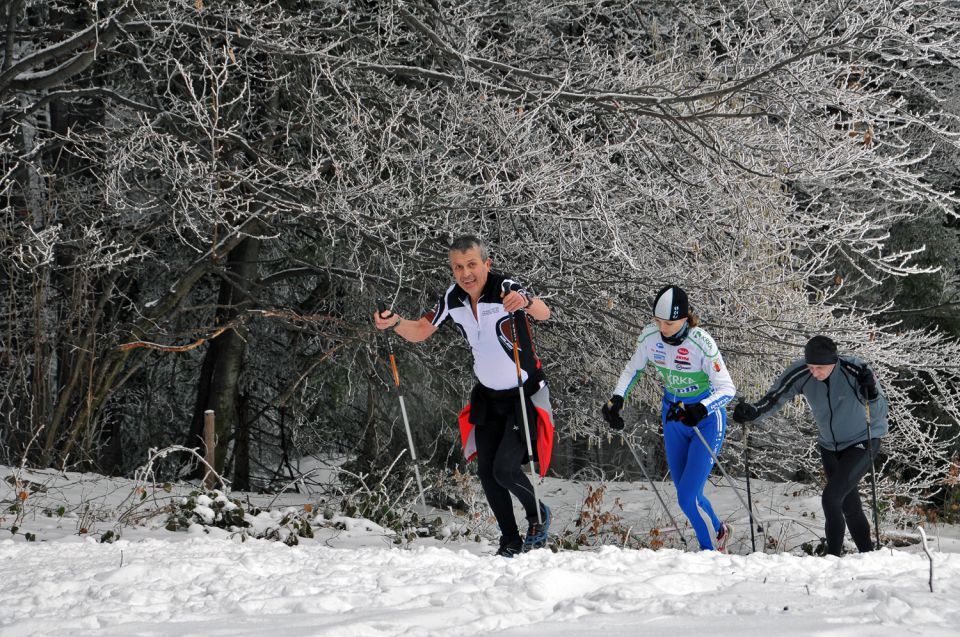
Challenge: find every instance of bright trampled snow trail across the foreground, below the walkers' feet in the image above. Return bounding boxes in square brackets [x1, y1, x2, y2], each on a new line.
[0, 537, 960, 637]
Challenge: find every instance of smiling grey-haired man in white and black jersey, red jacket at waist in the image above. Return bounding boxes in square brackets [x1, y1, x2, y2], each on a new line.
[374, 235, 553, 557]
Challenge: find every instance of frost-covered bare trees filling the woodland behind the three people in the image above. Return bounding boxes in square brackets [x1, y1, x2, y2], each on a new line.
[0, 0, 960, 520]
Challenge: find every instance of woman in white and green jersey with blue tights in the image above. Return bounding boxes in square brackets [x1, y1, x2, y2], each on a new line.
[602, 285, 736, 551]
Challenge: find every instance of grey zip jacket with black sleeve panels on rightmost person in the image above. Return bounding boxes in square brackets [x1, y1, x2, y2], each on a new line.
[754, 356, 888, 451]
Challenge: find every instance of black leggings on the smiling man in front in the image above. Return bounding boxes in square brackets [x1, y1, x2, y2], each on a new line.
[474, 400, 537, 538]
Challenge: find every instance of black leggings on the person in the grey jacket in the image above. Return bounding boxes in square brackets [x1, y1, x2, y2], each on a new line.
[820, 438, 880, 557]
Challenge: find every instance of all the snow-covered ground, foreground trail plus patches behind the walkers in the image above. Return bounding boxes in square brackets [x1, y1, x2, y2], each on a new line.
[0, 460, 960, 637]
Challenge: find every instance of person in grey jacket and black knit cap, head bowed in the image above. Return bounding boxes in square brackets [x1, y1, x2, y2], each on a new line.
[733, 336, 888, 557]
